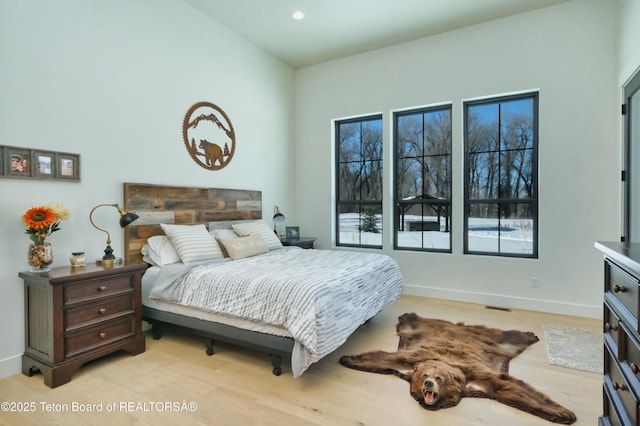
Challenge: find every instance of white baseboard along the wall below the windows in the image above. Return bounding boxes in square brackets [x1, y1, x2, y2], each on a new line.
[404, 284, 602, 319]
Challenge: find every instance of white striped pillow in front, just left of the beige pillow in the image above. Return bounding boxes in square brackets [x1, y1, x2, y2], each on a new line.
[160, 223, 224, 264]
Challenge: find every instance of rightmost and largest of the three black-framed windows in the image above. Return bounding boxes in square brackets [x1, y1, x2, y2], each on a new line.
[464, 93, 538, 258]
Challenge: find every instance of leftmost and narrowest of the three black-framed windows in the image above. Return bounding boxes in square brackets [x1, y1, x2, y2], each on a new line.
[335, 115, 383, 248]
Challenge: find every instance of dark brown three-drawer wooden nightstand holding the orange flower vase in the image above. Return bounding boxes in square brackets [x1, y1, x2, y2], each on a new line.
[19, 263, 147, 388]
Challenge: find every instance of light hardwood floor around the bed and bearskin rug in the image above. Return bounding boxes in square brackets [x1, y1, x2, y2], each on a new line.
[0, 296, 602, 426]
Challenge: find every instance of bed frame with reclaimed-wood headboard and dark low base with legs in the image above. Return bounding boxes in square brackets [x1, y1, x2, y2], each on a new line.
[124, 182, 294, 376]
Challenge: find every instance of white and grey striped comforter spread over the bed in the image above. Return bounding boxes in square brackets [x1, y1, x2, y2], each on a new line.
[150, 247, 403, 377]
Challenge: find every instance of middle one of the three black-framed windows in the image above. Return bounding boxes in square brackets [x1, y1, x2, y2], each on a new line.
[394, 106, 451, 253]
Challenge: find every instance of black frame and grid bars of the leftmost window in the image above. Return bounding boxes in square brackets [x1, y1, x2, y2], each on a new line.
[334, 114, 384, 249]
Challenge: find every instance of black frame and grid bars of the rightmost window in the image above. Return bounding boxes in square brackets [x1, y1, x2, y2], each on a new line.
[463, 91, 539, 259]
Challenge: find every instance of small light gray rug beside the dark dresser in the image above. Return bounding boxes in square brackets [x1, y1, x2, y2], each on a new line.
[542, 324, 604, 374]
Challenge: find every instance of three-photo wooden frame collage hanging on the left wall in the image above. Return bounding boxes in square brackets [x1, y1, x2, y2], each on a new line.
[0, 145, 80, 182]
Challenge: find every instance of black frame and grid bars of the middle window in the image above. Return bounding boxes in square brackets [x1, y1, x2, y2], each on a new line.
[393, 104, 453, 253]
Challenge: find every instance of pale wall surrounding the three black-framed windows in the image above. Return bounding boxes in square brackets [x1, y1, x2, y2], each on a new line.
[295, 0, 620, 318]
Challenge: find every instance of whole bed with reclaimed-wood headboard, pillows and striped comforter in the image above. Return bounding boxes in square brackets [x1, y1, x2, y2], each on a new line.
[124, 183, 403, 377]
